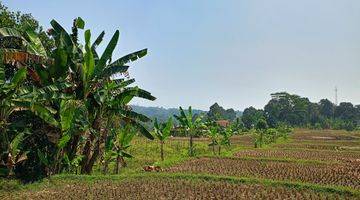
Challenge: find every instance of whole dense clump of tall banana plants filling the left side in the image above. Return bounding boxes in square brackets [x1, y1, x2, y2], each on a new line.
[0, 7, 155, 181]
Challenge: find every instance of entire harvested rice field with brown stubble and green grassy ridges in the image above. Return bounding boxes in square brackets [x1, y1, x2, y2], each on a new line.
[0, 130, 360, 199]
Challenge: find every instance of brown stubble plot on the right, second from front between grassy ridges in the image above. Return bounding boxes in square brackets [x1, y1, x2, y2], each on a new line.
[168, 158, 360, 189]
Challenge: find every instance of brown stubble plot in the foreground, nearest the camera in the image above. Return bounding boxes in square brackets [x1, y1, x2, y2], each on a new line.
[4, 178, 352, 200]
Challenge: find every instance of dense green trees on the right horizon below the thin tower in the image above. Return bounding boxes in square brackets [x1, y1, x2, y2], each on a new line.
[242, 92, 360, 130]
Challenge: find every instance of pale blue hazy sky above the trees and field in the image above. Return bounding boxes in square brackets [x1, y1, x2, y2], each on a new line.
[3, 0, 360, 110]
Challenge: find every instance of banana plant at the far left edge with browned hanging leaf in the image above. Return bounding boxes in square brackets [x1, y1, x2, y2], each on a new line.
[0, 25, 74, 177]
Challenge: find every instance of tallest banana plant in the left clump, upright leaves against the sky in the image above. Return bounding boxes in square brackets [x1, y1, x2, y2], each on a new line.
[25, 18, 155, 173]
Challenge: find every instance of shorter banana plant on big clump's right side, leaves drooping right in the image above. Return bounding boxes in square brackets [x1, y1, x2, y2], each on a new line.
[80, 79, 155, 173]
